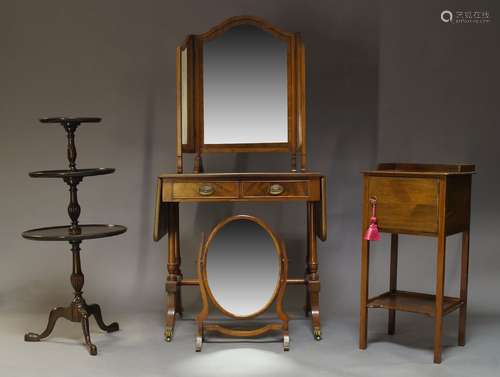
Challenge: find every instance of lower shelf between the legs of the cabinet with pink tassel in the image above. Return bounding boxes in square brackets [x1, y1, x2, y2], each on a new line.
[366, 291, 463, 317]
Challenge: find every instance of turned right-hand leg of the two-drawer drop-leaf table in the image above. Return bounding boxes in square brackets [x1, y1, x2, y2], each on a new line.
[306, 202, 321, 340]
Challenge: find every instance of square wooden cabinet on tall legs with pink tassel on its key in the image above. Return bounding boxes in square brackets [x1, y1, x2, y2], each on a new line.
[359, 163, 475, 363]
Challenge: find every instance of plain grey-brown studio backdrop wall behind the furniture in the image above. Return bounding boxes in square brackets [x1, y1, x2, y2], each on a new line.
[0, 0, 500, 320]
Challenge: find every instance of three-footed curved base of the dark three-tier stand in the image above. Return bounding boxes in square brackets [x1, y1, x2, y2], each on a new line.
[24, 298, 120, 356]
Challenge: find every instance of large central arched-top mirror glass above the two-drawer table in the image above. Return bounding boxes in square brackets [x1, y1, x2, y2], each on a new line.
[203, 25, 288, 144]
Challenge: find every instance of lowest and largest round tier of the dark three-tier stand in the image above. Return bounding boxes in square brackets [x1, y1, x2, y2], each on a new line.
[22, 224, 127, 241]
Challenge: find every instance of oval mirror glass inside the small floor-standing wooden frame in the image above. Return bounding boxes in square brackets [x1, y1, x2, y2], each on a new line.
[206, 219, 280, 317]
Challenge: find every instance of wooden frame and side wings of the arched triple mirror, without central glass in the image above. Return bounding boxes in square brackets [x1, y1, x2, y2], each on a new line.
[176, 16, 307, 173]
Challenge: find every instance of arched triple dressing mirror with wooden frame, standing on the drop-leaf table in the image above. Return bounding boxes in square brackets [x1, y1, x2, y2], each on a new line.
[177, 16, 306, 173]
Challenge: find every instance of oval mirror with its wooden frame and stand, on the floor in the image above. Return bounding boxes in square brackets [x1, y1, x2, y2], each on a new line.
[196, 215, 288, 351]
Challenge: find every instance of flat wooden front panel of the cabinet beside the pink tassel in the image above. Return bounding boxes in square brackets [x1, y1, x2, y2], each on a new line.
[366, 177, 439, 234]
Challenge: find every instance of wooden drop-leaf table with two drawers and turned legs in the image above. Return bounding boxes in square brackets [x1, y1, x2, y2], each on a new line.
[153, 172, 328, 341]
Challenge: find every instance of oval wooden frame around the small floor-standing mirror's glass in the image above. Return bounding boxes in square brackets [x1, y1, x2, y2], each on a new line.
[198, 215, 287, 319]
